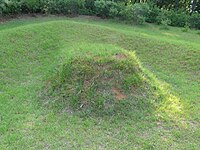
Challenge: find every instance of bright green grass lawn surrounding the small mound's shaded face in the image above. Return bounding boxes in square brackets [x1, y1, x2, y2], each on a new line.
[0, 17, 200, 150]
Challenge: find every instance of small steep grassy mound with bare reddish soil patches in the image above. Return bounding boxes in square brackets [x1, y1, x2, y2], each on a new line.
[43, 45, 158, 114]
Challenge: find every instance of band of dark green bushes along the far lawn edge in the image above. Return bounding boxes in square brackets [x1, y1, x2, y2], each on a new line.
[0, 0, 200, 29]
